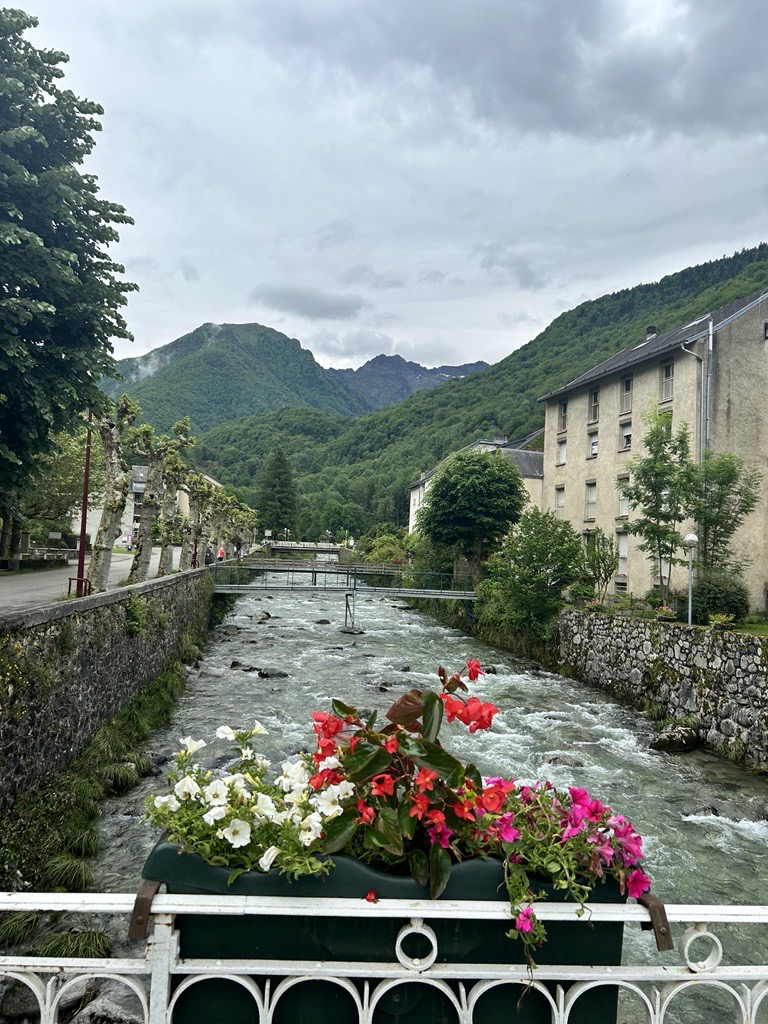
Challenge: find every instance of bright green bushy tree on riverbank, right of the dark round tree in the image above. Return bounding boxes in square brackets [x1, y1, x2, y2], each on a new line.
[476, 507, 584, 640]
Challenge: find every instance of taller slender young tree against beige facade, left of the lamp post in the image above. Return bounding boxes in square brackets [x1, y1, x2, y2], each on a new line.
[617, 408, 695, 600]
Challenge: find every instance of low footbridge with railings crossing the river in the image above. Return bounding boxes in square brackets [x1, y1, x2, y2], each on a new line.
[210, 558, 475, 601]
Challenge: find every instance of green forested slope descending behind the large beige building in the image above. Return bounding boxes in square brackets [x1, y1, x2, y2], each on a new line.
[194, 244, 768, 537]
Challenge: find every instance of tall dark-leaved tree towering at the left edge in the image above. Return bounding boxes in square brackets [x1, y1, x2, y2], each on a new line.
[0, 8, 135, 518]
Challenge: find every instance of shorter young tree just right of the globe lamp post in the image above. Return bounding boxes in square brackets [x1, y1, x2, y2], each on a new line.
[688, 450, 763, 571]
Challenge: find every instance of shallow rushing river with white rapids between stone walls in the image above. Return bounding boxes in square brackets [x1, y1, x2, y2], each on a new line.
[94, 590, 768, 1021]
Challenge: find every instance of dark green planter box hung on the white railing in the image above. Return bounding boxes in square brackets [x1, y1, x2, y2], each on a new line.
[142, 843, 624, 1024]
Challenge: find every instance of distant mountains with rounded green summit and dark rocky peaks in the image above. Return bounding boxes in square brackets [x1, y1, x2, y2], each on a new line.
[101, 324, 487, 433]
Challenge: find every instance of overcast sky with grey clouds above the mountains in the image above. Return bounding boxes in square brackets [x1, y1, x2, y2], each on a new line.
[27, 0, 768, 368]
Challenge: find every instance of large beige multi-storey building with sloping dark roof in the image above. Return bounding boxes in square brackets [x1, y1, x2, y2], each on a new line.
[541, 292, 768, 608]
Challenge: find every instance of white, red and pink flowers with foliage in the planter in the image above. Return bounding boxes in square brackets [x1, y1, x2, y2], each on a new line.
[146, 660, 649, 958]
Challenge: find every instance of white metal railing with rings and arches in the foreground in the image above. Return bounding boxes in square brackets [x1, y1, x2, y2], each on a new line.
[0, 893, 768, 1024]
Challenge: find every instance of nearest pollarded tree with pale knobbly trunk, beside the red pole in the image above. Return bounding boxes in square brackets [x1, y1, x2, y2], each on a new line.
[88, 394, 140, 591]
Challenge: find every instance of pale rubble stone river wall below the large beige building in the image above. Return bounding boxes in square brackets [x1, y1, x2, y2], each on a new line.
[559, 611, 768, 767]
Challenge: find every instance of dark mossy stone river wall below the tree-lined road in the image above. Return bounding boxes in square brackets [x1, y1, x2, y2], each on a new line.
[0, 569, 213, 811]
